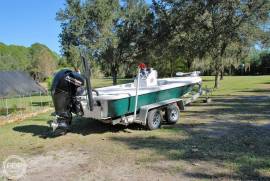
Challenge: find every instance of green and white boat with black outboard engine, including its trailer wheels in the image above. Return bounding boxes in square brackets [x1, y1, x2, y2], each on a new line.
[51, 60, 202, 134]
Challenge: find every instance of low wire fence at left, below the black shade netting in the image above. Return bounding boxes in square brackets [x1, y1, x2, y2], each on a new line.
[0, 92, 53, 119]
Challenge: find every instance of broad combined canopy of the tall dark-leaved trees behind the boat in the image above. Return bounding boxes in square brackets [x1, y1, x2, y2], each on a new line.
[57, 0, 270, 87]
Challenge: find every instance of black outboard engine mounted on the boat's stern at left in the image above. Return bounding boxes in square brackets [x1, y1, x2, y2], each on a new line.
[51, 69, 84, 132]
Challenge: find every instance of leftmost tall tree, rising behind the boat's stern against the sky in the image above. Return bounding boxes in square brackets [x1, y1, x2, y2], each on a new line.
[57, 0, 119, 83]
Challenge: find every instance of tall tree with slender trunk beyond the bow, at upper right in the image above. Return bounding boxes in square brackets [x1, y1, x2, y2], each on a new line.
[198, 0, 270, 88]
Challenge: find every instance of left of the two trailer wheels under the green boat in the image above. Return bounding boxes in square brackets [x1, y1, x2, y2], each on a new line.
[146, 109, 162, 130]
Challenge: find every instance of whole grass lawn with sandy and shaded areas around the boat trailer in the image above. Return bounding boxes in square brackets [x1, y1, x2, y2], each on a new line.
[0, 76, 270, 180]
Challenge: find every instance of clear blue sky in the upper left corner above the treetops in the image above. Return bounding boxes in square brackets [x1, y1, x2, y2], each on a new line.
[0, 0, 65, 53]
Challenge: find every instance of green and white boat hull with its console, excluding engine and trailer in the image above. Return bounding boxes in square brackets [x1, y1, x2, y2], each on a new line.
[81, 69, 202, 120]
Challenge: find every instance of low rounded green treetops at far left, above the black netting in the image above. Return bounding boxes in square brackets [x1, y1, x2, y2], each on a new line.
[0, 43, 59, 80]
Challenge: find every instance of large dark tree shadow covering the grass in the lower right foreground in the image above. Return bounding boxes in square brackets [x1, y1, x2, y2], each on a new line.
[111, 122, 270, 180]
